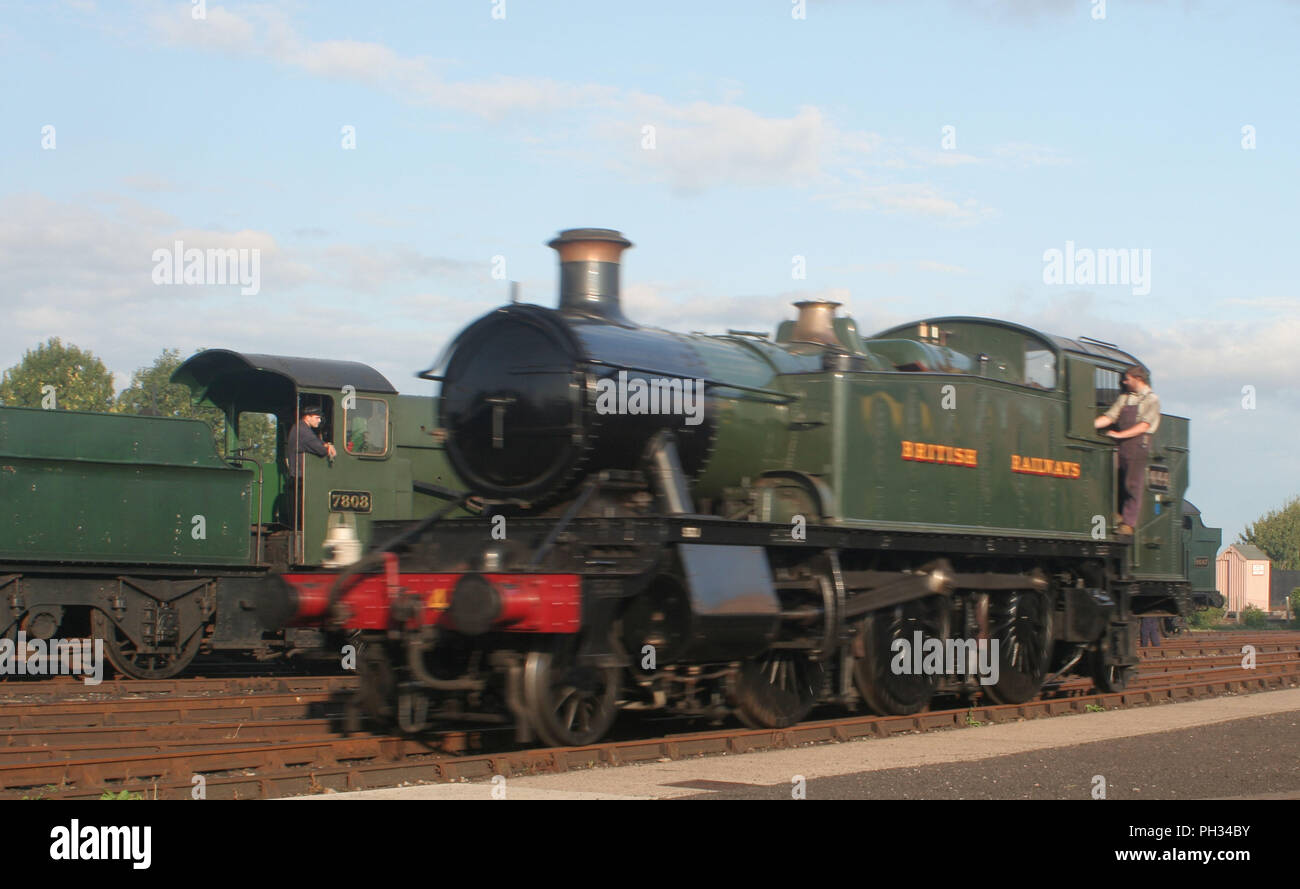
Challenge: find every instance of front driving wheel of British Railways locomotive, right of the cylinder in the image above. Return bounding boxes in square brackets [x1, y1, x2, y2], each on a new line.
[732, 649, 826, 728]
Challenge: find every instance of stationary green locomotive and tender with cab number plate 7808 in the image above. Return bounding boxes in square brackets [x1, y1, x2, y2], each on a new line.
[0, 348, 465, 678]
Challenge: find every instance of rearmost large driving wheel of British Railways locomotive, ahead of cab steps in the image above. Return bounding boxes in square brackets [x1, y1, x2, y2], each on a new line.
[982, 590, 1052, 703]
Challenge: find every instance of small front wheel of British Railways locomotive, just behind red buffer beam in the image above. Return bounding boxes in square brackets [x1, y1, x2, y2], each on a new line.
[524, 645, 621, 747]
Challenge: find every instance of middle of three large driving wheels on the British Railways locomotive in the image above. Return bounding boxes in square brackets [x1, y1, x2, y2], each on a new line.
[853, 599, 946, 716]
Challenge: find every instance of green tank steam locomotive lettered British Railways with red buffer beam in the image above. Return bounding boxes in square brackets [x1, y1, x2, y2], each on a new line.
[260, 229, 1216, 746]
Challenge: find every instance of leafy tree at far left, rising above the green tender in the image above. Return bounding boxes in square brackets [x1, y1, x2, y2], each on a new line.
[0, 337, 113, 411]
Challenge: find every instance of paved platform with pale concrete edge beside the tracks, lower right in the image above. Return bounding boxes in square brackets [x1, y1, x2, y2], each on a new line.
[289, 689, 1300, 799]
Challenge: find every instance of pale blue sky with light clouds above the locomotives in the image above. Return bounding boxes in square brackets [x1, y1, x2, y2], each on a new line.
[0, 0, 1300, 543]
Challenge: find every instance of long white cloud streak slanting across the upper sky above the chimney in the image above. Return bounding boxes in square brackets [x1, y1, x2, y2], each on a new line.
[144, 4, 984, 221]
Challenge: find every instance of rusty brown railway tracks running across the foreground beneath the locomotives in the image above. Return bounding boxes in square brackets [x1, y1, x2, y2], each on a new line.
[0, 633, 1300, 799]
